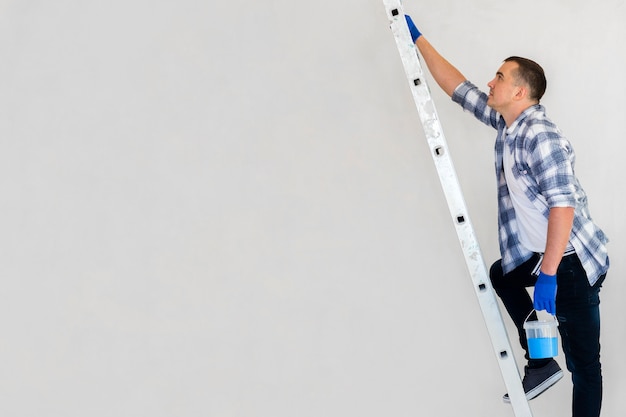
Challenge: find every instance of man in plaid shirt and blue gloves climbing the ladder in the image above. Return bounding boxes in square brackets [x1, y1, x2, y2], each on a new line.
[386, 2, 609, 417]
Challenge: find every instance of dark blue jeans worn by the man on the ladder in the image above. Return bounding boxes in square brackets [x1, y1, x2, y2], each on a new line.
[489, 250, 606, 417]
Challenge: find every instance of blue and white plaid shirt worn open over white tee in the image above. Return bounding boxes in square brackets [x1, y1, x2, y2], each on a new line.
[452, 81, 609, 285]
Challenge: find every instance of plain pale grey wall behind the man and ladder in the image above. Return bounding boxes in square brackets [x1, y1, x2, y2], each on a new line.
[0, 0, 626, 417]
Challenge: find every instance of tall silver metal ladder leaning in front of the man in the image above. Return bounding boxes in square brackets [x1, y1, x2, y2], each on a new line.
[383, 0, 532, 417]
